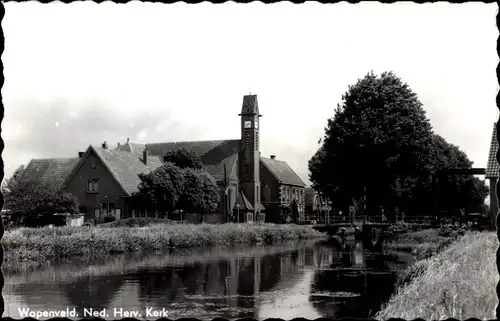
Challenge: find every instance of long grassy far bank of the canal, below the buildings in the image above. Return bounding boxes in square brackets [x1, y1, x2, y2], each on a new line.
[2, 224, 326, 269]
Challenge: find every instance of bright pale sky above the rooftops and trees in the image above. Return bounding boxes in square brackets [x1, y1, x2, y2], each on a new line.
[1, 2, 499, 188]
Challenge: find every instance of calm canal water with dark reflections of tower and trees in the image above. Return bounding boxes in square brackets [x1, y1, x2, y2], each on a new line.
[4, 242, 410, 319]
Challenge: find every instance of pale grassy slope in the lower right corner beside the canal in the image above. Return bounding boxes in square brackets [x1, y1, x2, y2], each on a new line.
[375, 232, 499, 320]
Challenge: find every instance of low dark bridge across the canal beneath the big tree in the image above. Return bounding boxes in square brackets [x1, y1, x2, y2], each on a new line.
[308, 217, 390, 248]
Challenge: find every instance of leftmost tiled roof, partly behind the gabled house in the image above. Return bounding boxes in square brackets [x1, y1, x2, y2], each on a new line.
[22, 158, 80, 189]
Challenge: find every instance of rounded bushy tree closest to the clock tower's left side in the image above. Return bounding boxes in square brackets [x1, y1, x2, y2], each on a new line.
[179, 168, 220, 213]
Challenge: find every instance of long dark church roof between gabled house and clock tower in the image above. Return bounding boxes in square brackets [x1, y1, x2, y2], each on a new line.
[117, 139, 240, 182]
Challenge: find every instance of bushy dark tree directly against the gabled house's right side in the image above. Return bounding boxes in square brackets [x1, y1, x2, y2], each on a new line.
[133, 163, 184, 214]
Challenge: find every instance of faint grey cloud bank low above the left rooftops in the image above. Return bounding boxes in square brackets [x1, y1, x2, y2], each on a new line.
[2, 96, 205, 176]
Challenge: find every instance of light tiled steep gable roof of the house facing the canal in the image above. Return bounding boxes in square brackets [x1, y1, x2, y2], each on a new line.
[65, 146, 162, 196]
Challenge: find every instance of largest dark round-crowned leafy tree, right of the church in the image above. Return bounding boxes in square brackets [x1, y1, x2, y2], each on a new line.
[309, 72, 432, 214]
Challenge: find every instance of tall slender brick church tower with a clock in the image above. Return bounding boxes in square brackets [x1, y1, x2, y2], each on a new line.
[238, 95, 261, 216]
